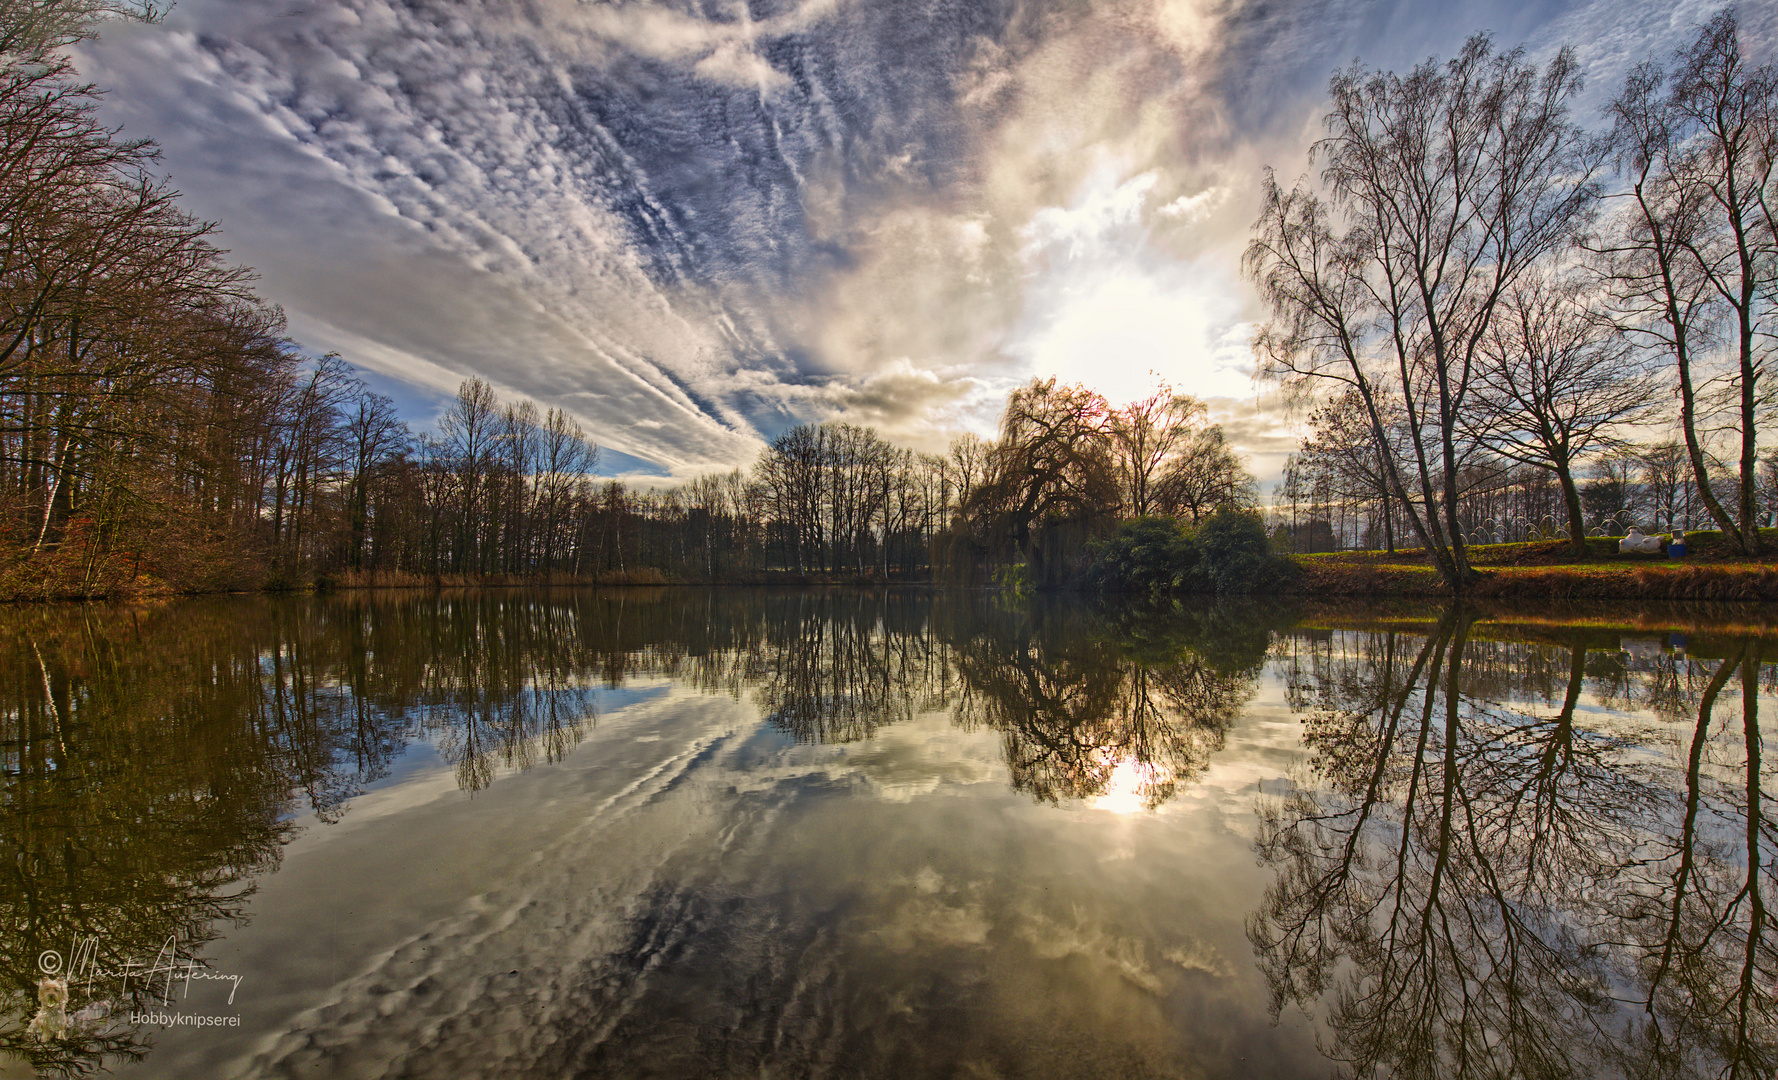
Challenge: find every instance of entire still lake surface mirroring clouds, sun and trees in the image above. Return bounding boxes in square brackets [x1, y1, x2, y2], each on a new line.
[0, 589, 1778, 1078]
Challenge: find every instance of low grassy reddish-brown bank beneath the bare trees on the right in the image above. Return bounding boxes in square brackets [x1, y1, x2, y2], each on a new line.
[1287, 528, 1778, 601]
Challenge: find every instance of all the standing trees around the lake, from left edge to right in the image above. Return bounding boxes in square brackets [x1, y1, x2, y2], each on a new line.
[0, 0, 1778, 598]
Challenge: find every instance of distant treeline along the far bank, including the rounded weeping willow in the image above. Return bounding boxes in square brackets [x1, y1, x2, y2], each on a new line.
[323, 371, 1255, 585]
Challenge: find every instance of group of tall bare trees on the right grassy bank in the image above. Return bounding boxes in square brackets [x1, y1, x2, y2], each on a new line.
[1246, 9, 1778, 591]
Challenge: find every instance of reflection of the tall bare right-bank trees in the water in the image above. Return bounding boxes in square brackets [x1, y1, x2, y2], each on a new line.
[1248, 612, 1778, 1076]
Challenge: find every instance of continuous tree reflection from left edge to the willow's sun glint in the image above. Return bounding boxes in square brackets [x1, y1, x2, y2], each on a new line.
[0, 591, 1266, 1071]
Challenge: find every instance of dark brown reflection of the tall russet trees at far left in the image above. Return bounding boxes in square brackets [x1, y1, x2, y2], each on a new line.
[0, 610, 299, 1073]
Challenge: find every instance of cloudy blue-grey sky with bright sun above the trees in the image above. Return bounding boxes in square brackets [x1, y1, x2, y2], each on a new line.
[78, 0, 1778, 479]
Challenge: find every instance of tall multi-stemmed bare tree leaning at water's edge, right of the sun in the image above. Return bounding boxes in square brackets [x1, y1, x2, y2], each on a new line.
[1245, 34, 1598, 592]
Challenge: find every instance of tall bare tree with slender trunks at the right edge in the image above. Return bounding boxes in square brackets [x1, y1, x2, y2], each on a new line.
[1597, 9, 1778, 553]
